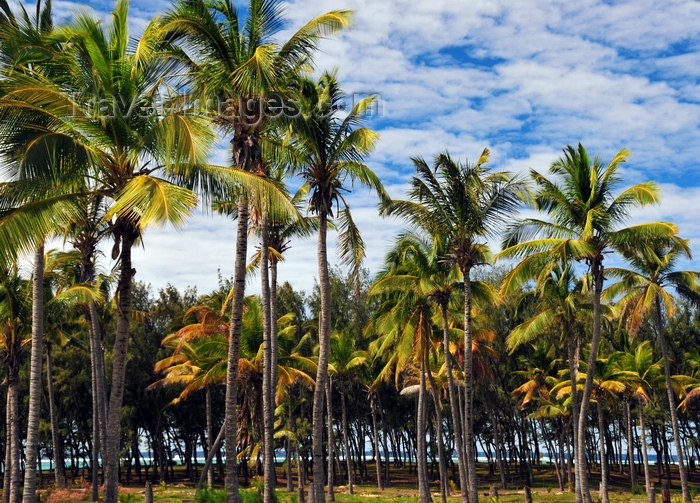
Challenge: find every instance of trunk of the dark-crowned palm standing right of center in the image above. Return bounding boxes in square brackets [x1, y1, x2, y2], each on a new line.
[461, 266, 479, 503]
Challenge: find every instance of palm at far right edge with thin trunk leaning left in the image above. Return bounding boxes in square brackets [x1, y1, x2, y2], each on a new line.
[606, 237, 700, 501]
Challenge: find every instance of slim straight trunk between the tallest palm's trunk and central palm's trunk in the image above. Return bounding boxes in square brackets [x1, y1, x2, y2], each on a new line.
[260, 215, 276, 503]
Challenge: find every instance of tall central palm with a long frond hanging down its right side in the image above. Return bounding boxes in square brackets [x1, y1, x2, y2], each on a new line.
[291, 73, 388, 503]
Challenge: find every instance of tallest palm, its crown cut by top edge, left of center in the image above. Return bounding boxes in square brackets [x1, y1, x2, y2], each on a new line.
[164, 0, 349, 503]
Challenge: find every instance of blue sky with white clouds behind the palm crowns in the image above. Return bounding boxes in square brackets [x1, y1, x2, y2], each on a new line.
[47, 0, 700, 293]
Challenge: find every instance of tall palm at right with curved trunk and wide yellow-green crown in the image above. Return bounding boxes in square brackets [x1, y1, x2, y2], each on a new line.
[499, 144, 676, 503]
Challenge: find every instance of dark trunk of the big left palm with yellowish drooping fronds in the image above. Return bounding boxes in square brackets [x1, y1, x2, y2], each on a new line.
[104, 228, 137, 503]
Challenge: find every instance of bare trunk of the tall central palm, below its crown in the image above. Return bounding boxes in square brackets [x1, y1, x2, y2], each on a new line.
[311, 212, 331, 503]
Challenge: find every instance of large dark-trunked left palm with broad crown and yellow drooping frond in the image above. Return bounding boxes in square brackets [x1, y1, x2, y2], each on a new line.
[0, 0, 224, 503]
